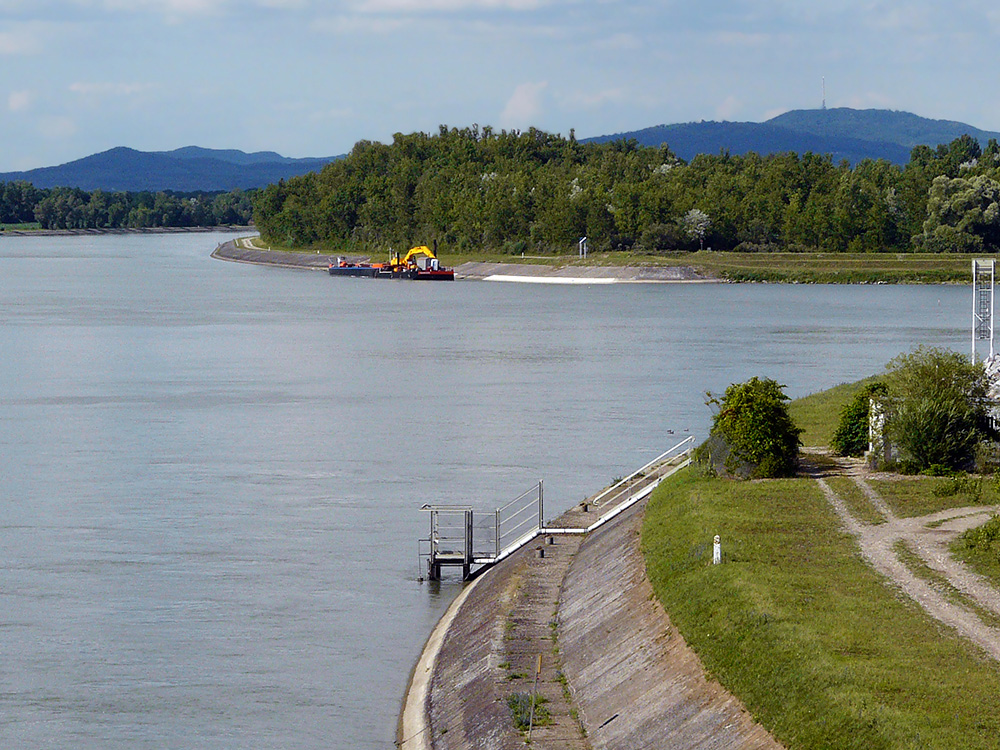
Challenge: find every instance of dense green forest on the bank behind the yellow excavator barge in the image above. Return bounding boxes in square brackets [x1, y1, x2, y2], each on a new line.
[254, 126, 1000, 253]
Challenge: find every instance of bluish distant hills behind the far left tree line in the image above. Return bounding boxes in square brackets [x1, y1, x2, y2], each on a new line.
[0, 146, 340, 192]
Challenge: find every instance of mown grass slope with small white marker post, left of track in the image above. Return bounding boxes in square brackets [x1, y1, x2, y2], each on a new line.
[642, 471, 1000, 750]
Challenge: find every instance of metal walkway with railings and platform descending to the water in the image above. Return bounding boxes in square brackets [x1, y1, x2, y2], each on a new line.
[417, 436, 694, 581]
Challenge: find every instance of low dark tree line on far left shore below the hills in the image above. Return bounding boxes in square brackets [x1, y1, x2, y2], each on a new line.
[0, 180, 253, 229]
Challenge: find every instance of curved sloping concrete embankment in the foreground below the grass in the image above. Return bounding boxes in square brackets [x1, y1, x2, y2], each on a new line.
[398, 482, 780, 750]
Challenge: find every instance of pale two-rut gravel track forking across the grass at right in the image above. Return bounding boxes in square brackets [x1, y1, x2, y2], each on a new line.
[816, 472, 1000, 661]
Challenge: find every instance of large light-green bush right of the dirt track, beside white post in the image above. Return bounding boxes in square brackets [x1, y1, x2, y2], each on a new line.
[885, 347, 996, 471]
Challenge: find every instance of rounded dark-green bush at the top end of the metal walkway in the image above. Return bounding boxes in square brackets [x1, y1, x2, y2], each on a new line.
[699, 378, 802, 479]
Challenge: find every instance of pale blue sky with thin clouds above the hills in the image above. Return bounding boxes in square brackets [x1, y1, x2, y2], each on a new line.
[0, 0, 1000, 171]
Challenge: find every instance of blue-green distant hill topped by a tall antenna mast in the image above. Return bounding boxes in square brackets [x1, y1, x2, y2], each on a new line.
[585, 108, 1000, 164]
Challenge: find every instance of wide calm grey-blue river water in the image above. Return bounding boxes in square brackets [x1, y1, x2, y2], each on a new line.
[0, 235, 971, 750]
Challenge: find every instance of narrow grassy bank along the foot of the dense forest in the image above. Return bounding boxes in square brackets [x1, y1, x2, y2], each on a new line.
[252, 236, 982, 284]
